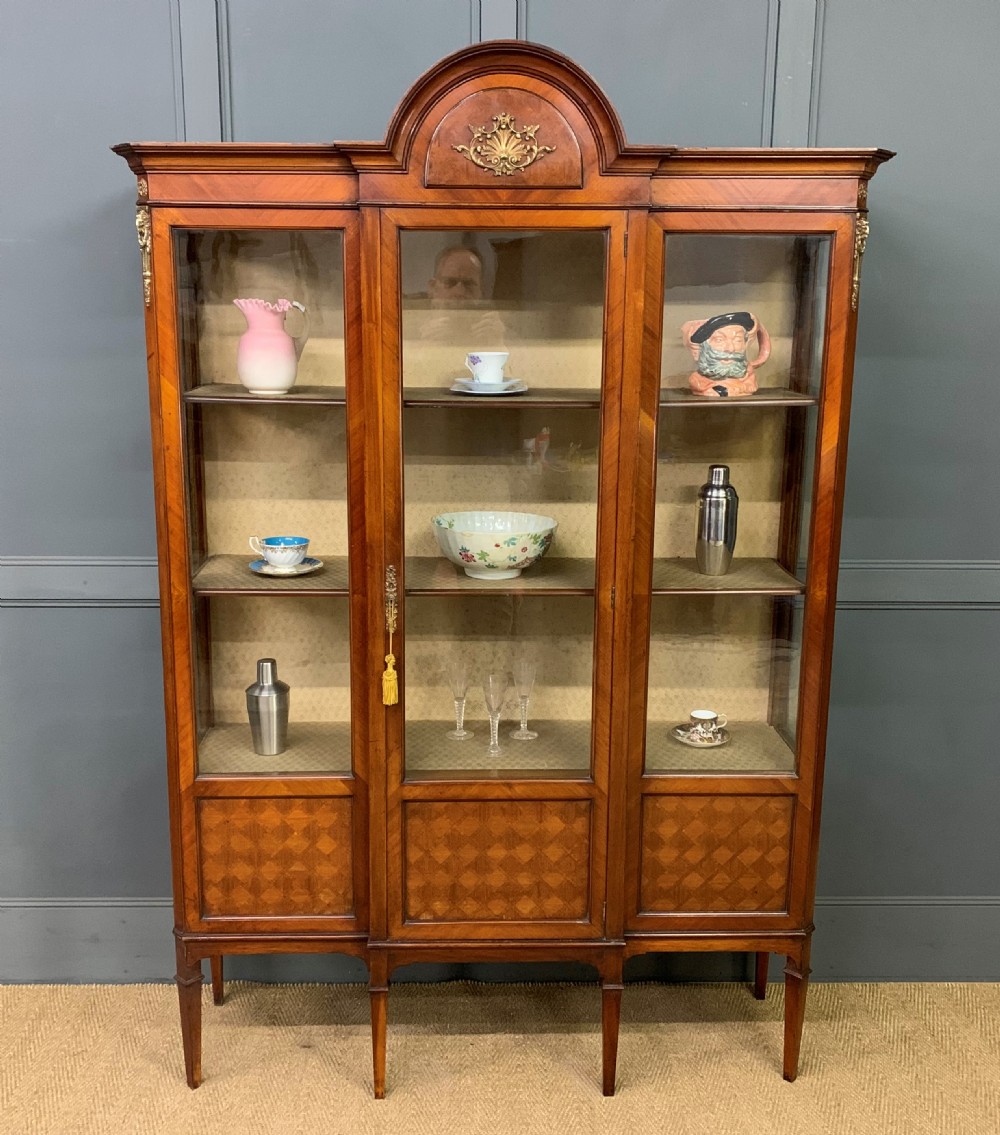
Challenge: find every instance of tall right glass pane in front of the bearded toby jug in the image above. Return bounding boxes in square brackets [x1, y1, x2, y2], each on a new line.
[646, 234, 830, 773]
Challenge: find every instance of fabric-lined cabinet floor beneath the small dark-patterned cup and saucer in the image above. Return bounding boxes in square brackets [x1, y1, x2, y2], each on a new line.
[646, 721, 796, 775]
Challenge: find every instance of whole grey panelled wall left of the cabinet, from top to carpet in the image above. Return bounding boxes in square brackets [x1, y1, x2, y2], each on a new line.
[0, 0, 180, 981]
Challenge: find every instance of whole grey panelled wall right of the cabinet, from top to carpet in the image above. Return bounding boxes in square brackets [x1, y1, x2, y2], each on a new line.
[813, 0, 1000, 978]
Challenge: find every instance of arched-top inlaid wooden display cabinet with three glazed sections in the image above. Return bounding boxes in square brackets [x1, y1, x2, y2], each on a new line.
[116, 42, 890, 1096]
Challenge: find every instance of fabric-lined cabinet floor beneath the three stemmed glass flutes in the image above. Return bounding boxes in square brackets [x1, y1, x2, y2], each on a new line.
[405, 717, 590, 780]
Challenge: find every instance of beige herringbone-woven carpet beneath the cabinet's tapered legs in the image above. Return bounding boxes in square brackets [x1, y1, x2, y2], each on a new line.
[0, 982, 1000, 1135]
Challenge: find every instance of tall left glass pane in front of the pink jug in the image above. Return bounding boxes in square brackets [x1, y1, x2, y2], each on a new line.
[175, 230, 351, 775]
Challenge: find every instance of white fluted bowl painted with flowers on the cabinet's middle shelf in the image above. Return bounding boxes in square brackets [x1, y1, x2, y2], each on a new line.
[432, 511, 558, 579]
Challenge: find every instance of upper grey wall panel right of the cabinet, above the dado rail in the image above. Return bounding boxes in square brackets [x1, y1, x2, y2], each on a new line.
[816, 0, 1000, 562]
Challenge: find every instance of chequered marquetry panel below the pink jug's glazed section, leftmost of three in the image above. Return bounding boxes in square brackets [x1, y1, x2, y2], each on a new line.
[198, 797, 354, 918]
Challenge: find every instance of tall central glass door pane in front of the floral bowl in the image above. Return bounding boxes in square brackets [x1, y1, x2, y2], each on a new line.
[401, 230, 607, 776]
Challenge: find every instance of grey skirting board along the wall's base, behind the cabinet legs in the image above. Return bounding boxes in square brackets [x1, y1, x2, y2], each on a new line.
[0, 894, 1000, 984]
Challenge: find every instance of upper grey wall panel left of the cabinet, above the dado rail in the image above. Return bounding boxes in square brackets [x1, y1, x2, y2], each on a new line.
[0, 0, 177, 549]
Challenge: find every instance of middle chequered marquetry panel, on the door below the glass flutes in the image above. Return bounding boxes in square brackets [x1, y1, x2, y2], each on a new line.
[403, 800, 590, 922]
